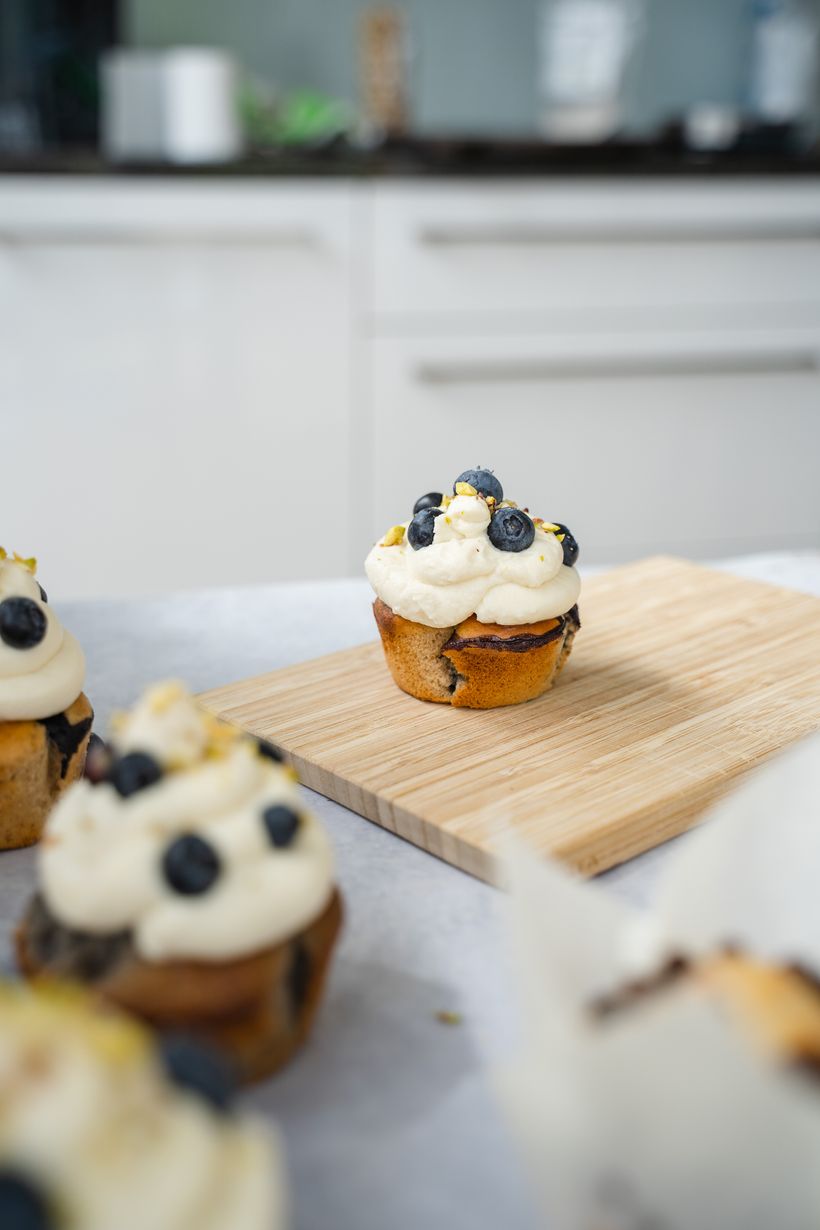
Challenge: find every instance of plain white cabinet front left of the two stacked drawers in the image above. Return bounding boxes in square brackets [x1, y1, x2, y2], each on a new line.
[0, 178, 352, 598]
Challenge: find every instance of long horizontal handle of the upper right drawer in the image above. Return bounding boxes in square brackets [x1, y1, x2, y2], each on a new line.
[417, 219, 820, 247]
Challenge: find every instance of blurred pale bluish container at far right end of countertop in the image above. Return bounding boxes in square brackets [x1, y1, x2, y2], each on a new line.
[750, 0, 819, 124]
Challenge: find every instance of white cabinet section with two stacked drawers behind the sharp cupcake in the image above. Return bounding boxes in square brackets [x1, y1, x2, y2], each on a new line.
[361, 180, 820, 562]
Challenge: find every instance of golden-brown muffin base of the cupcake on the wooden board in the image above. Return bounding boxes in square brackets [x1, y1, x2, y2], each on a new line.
[373, 598, 580, 708]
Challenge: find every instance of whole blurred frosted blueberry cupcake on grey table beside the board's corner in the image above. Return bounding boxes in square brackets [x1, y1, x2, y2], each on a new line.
[17, 683, 342, 1081]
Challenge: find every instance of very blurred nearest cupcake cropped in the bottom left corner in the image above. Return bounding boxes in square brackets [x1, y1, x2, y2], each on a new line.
[0, 984, 285, 1230]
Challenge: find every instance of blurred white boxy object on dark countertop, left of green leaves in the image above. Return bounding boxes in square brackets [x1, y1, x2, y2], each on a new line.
[102, 47, 242, 165]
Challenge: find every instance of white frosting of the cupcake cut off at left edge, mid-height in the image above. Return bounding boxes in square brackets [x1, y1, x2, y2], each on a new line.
[0, 558, 85, 722]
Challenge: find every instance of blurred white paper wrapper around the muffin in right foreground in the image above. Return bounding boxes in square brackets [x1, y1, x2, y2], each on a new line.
[499, 734, 820, 1230]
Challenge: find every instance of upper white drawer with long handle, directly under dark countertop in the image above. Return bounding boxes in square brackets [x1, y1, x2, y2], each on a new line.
[373, 181, 820, 327]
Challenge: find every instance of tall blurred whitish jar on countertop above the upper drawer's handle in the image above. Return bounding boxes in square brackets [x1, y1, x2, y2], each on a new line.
[538, 0, 643, 141]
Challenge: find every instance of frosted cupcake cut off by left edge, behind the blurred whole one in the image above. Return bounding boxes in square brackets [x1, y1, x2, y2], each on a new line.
[0, 547, 93, 850]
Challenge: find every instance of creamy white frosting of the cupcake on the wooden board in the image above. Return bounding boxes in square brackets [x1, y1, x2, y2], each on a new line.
[365, 496, 580, 627]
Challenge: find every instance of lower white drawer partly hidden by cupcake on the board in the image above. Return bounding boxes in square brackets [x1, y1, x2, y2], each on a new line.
[363, 331, 820, 561]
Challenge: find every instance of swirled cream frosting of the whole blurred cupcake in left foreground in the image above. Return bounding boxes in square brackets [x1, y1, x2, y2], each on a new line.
[39, 684, 333, 961]
